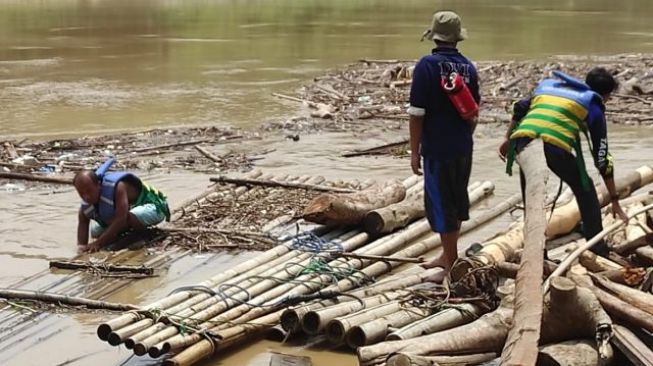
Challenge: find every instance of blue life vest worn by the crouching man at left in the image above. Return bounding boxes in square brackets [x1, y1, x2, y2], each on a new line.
[82, 172, 142, 227]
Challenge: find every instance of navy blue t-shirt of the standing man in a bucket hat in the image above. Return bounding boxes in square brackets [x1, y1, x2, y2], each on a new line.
[410, 47, 481, 160]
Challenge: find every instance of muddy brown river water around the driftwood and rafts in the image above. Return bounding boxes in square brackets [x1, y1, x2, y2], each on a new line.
[0, 0, 653, 366]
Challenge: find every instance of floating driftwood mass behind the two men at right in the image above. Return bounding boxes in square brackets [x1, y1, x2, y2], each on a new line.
[268, 54, 653, 136]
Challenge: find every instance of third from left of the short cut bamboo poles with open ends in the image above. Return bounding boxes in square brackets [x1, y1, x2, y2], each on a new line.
[325, 301, 402, 345]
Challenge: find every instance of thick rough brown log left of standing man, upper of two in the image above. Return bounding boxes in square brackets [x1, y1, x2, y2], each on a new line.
[302, 181, 406, 225]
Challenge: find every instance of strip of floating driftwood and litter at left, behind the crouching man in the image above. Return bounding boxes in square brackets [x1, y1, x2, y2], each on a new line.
[0, 127, 266, 179]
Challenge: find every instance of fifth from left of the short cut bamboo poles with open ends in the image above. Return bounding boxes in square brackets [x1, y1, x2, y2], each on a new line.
[386, 303, 482, 341]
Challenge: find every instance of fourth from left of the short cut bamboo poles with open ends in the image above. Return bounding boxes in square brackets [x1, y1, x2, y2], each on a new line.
[346, 307, 430, 349]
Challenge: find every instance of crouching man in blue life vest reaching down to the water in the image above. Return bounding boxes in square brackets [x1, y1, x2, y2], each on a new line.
[73, 160, 170, 252]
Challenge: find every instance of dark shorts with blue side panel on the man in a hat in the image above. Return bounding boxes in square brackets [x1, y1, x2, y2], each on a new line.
[424, 155, 472, 233]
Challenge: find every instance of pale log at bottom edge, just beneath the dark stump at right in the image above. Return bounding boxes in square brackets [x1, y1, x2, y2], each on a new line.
[537, 339, 613, 366]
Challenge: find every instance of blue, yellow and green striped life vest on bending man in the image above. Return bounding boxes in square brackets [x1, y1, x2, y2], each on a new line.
[510, 71, 600, 152]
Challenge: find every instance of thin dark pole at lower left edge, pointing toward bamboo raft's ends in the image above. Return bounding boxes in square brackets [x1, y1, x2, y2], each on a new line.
[0, 289, 140, 311]
